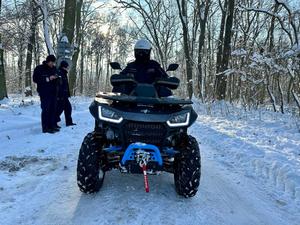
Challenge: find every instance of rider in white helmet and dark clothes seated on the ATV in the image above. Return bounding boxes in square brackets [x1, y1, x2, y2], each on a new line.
[113, 39, 172, 97]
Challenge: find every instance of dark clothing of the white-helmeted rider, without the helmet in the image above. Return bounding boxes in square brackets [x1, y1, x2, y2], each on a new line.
[113, 60, 172, 96]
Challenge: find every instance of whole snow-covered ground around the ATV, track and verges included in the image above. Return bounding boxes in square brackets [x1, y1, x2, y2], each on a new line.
[0, 98, 300, 225]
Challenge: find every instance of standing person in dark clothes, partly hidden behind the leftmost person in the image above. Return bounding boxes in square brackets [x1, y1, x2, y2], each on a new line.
[56, 61, 76, 128]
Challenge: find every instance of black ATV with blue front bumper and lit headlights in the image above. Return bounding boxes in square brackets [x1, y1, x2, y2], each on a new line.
[77, 63, 201, 197]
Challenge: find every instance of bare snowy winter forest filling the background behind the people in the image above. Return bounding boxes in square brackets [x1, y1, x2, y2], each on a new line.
[0, 0, 300, 115]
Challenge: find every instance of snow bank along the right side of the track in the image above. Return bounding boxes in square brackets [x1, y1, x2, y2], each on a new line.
[192, 101, 300, 203]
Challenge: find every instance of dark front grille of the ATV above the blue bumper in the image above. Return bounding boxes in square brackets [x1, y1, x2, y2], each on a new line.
[123, 122, 166, 146]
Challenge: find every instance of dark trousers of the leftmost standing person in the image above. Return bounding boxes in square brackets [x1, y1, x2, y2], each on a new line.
[40, 95, 56, 131]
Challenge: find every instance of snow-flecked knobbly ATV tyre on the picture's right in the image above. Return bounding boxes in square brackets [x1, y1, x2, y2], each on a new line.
[174, 136, 201, 198]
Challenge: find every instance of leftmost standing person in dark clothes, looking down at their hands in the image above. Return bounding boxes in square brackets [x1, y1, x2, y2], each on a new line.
[33, 55, 59, 134]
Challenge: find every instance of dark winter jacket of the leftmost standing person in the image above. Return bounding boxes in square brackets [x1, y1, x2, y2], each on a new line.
[33, 61, 57, 96]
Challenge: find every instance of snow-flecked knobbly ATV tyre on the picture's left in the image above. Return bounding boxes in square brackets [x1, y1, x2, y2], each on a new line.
[77, 132, 105, 193]
